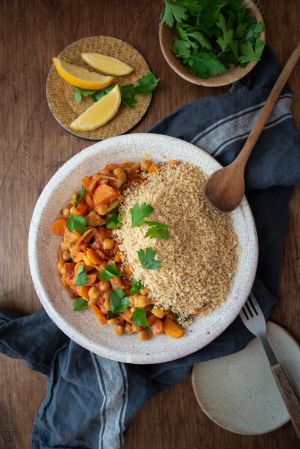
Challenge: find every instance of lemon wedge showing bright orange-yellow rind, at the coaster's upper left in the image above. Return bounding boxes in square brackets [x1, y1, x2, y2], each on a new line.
[53, 58, 113, 90]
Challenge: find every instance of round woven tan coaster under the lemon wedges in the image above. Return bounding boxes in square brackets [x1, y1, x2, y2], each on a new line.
[46, 36, 151, 140]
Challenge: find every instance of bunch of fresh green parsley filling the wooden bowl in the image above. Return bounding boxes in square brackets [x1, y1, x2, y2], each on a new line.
[161, 0, 264, 78]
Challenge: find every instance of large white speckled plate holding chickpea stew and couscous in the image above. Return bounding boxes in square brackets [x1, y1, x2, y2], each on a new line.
[28, 134, 258, 364]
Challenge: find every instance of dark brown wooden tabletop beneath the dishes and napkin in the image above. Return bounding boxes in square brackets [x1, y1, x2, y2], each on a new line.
[0, 0, 300, 449]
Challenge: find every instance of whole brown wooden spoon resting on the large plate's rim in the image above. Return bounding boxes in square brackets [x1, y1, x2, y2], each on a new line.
[205, 41, 300, 212]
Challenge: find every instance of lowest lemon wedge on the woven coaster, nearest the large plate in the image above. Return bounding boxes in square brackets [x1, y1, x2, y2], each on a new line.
[70, 84, 121, 131]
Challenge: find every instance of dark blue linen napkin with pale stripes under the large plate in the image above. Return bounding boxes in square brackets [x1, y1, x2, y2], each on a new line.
[0, 49, 300, 449]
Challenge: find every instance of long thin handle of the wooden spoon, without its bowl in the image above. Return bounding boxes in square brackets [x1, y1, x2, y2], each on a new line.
[236, 41, 300, 166]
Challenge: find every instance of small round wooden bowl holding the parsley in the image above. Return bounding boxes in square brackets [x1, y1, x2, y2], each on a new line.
[159, 0, 265, 87]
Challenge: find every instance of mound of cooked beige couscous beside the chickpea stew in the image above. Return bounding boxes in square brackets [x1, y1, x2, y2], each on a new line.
[114, 162, 238, 325]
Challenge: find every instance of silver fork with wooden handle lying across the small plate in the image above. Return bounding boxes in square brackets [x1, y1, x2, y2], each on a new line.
[240, 292, 300, 438]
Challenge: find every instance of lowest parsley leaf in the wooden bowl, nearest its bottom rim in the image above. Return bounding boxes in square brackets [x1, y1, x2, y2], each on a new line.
[189, 52, 226, 78]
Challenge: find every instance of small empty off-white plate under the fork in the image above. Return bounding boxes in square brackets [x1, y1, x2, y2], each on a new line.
[192, 322, 300, 435]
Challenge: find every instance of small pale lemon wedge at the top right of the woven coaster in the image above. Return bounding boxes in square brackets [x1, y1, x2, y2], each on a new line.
[81, 53, 133, 76]
